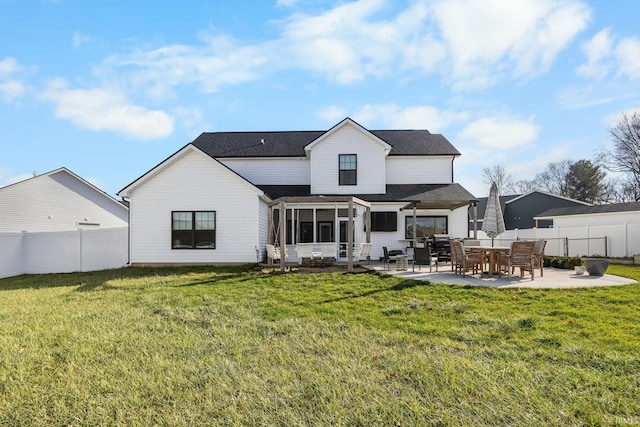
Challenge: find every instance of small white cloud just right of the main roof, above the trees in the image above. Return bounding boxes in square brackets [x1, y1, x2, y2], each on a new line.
[458, 117, 539, 150]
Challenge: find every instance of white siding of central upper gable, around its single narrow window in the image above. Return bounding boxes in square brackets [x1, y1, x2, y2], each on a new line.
[310, 125, 386, 194]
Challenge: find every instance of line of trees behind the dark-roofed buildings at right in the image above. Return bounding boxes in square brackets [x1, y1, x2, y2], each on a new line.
[482, 113, 640, 204]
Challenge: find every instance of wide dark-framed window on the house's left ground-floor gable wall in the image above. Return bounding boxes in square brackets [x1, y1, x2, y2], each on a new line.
[171, 211, 216, 249]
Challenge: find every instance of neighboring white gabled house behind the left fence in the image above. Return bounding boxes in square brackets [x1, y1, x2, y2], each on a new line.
[0, 171, 128, 232]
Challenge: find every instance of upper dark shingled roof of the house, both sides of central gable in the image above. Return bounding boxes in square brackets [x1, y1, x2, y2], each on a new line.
[192, 130, 460, 157]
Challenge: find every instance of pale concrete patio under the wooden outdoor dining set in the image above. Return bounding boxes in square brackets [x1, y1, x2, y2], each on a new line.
[362, 262, 636, 289]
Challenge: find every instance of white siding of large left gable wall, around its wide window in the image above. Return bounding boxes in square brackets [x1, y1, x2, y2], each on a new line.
[130, 151, 260, 264]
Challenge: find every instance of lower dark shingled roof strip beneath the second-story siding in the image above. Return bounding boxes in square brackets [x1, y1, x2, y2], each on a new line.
[257, 184, 475, 202]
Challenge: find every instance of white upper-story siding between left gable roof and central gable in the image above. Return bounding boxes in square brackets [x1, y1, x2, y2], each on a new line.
[218, 157, 311, 185]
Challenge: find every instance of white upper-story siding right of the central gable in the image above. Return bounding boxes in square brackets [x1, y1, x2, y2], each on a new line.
[386, 156, 453, 184]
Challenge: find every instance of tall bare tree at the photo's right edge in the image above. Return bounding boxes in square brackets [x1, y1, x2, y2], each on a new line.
[598, 113, 640, 201]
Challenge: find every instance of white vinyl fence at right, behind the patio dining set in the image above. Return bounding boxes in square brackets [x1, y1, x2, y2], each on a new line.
[472, 223, 640, 258]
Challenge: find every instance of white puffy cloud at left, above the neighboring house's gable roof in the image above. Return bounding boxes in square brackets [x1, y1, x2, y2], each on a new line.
[43, 79, 174, 140]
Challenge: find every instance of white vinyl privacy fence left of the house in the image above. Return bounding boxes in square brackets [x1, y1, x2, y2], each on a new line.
[0, 227, 129, 278]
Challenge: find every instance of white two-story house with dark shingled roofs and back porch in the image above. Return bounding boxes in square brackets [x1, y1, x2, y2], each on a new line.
[118, 118, 477, 264]
